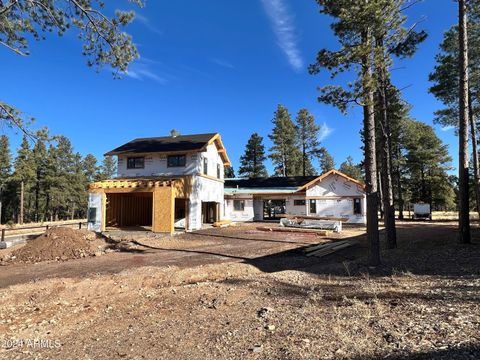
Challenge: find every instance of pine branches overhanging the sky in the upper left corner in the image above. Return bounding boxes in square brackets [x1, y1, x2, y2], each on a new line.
[0, 0, 142, 132]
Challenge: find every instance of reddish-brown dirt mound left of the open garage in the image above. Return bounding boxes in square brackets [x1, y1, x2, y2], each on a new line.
[11, 228, 103, 262]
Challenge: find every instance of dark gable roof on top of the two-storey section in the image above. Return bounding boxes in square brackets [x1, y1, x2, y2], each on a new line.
[105, 133, 230, 166]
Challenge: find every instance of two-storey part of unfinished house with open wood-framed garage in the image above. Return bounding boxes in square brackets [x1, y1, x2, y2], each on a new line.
[88, 133, 230, 233]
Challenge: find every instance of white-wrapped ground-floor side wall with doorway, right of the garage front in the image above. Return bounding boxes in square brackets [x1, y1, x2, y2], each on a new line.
[188, 175, 225, 230]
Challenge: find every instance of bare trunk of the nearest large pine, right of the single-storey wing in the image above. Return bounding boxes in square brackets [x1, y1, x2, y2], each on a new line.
[362, 29, 380, 266]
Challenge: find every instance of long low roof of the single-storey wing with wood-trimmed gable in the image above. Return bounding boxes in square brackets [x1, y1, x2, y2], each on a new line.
[225, 170, 365, 193]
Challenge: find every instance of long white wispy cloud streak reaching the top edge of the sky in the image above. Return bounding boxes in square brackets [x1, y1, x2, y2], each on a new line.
[262, 0, 303, 71]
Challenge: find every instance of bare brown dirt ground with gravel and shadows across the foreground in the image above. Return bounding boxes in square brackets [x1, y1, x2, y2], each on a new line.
[0, 222, 480, 359]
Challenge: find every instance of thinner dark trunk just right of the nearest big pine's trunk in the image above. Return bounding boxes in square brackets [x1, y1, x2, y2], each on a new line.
[377, 52, 397, 249]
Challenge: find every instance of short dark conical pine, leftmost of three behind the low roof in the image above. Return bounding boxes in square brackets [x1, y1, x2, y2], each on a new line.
[238, 133, 268, 178]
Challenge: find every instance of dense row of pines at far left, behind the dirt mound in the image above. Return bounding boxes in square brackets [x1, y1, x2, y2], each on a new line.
[0, 129, 116, 224]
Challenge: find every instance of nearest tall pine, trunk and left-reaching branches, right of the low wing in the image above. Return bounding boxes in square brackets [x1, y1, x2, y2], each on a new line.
[309, 0, 382, 266]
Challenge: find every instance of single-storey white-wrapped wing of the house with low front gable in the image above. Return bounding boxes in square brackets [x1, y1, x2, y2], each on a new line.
[225, 170, 366, 224]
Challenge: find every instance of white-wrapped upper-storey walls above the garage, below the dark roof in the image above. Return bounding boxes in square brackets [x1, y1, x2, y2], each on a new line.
[117, 144, 223, 179]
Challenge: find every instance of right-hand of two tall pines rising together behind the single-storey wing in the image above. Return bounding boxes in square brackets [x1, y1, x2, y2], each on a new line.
[296, 109, 320, 176]
